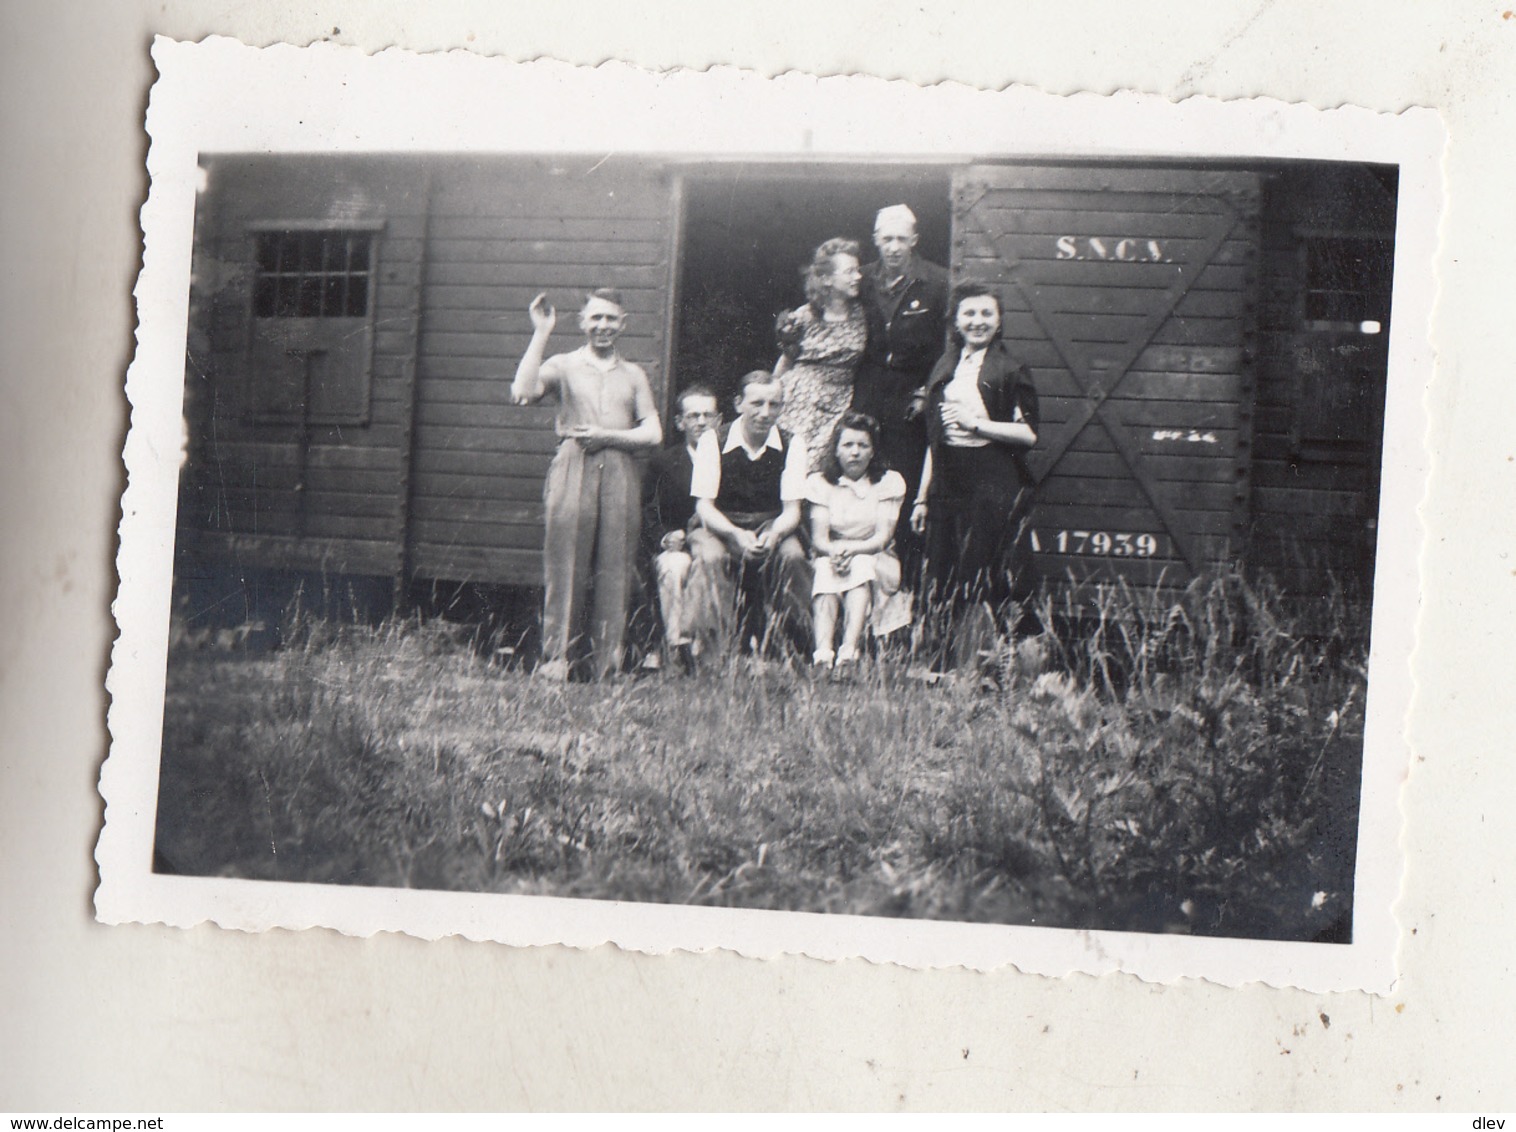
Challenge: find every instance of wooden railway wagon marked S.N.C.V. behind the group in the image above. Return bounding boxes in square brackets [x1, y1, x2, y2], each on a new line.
[179, 155, 1396, 621]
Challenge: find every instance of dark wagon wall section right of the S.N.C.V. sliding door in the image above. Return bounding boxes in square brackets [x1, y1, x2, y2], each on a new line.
[1249, 165, 1395, 600]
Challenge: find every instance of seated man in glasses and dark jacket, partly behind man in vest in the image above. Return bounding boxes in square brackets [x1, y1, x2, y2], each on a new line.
[643, 385, 722, 671]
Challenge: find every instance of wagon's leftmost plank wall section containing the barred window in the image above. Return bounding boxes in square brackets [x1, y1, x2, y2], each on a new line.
[179, 155, 426, 574]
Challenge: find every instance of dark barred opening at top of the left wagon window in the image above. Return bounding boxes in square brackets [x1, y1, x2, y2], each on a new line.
[253, 230, 373, 318]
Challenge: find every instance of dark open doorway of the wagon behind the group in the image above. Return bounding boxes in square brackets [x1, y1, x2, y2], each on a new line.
[669, 162, 951, 406]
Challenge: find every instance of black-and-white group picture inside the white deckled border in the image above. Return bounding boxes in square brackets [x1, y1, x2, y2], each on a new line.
[97, 39, 1434, 988]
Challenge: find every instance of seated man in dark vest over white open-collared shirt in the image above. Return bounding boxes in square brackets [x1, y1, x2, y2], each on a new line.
[687, 370, 811, 652]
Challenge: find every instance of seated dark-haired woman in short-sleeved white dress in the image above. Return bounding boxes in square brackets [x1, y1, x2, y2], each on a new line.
[805, 412, 905, 668]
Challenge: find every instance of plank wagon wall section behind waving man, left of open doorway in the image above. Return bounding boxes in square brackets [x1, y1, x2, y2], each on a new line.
[409, 158, 672, 585]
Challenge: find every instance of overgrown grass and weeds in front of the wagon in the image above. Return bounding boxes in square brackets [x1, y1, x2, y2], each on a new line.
[158, 583, 1363, 940]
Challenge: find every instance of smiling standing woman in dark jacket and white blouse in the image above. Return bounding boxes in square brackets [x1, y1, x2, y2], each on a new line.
[911, 283, 1038, 660]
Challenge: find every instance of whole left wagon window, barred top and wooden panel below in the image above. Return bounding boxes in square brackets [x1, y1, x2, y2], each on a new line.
[244, 220, 379, 424]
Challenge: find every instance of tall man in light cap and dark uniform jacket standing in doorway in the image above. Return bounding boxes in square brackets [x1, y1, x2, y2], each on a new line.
[852, 205, 948, 586]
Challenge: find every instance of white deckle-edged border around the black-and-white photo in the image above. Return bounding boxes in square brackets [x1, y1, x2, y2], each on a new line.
[96, 38, 1445, 994]
